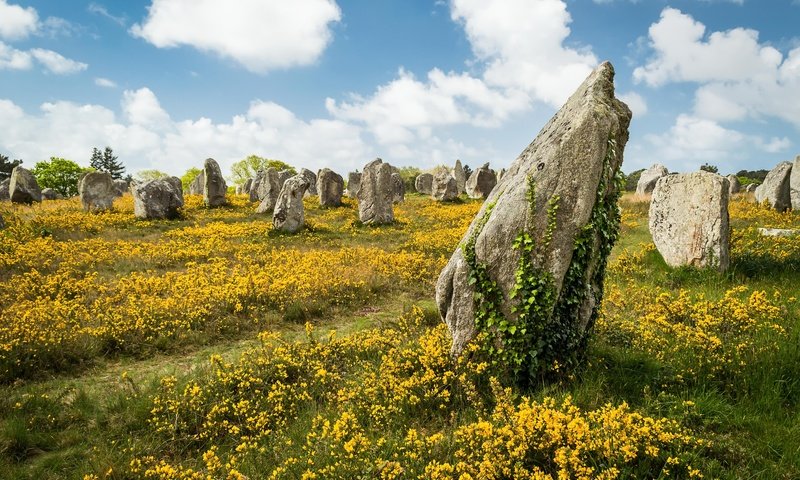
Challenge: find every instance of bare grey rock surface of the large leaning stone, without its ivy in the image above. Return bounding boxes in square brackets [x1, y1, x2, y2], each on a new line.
[436, 62, 631, 355]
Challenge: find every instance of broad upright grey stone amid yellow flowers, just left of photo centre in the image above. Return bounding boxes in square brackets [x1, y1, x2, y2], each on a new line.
[358, 158, 394, 225]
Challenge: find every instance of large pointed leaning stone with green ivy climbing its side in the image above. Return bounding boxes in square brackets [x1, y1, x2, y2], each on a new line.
[436, 62, 631, 364]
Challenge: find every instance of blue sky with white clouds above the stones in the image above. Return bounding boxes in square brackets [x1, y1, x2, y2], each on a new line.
[0, 0, 800, 180]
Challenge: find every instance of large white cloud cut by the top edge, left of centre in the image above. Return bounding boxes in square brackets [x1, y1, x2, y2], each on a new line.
[131, 0, 341, 73]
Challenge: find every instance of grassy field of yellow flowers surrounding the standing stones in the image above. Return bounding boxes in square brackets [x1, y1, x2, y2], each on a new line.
[0, 195, 800, 480]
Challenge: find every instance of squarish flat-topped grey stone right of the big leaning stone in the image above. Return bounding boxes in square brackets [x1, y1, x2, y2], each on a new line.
[650, 171, 730, 271]
